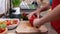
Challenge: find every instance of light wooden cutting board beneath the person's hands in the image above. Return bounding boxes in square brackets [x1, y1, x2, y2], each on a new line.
[16, 21, 47, 34]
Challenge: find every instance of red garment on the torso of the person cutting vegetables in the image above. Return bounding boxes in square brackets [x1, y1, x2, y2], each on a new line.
[51, 0, 60, 34]
